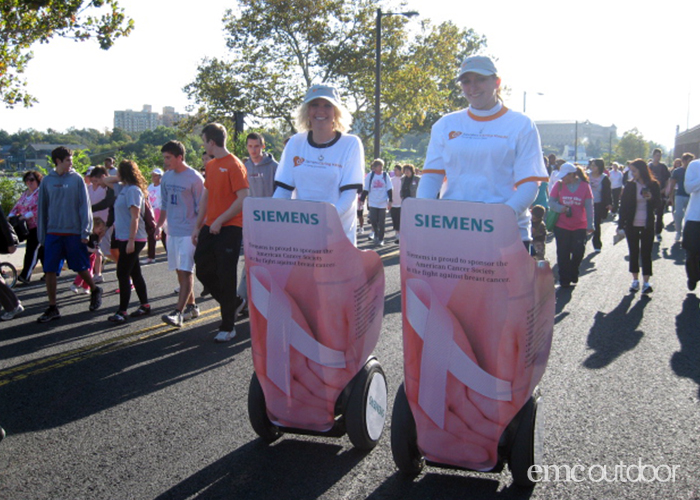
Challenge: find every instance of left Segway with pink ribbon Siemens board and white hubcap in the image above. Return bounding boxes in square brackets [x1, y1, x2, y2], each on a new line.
[243, 198, 387, 450]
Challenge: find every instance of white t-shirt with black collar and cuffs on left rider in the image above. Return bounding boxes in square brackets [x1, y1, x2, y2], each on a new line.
[275, 132, 365, 243]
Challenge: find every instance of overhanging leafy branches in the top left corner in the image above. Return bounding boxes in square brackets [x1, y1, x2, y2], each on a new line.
[0, 0, 134, 108]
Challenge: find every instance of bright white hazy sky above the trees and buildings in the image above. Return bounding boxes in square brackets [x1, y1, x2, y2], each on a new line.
[0, 0, 700, 148]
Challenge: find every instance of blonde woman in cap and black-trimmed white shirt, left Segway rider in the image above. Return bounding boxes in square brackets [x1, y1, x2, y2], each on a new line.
[274, 84, 365, 245]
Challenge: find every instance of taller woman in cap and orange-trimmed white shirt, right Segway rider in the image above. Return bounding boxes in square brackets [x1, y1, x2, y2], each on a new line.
[417, 56, 549, 246]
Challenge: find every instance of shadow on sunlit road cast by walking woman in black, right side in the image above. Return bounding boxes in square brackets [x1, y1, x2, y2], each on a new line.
[583, 293, 649, 370]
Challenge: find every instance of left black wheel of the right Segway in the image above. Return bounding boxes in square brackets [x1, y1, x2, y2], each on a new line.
[391, 384, 425, 476]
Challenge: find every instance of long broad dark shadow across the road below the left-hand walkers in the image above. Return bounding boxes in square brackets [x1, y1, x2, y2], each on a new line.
[0, 321, 250, 434]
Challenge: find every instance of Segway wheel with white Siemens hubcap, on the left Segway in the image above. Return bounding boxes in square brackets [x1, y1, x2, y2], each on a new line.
[345, 359, 387, 450]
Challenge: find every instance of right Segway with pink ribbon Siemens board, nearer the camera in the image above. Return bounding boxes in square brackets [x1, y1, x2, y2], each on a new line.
[391, 198, 555, 486]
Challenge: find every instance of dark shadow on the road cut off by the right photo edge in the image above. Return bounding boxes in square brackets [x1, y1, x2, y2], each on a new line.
[671, 293, 700, 399]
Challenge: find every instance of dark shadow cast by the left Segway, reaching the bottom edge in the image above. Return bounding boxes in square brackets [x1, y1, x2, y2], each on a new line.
[156, 435, 366, 500]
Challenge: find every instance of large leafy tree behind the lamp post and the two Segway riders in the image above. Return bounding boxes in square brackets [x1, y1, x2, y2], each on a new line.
[185, 0, 486, 145]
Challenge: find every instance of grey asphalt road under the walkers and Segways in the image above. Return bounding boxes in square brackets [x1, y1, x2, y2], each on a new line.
[0, 218, 700, 500]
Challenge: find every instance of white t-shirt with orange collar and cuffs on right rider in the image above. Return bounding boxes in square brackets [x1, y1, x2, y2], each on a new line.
[423, 106, 549, 236]
